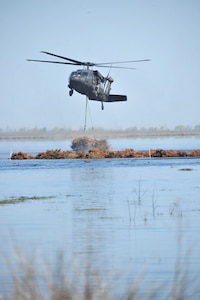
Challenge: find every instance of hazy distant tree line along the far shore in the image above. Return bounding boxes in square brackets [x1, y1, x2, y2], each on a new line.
[0, 124, 200, 139]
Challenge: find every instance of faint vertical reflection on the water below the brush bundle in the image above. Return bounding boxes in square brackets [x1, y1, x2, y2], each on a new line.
[70, 162, 114, 262]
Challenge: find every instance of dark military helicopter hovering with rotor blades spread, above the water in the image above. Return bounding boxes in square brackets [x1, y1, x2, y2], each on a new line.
[27, 51, 150, 110]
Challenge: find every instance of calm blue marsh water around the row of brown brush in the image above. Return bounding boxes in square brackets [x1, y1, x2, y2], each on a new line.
[0, 138, 200, 294]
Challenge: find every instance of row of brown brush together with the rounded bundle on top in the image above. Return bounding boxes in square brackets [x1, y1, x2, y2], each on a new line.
[11, 137, 200, 159]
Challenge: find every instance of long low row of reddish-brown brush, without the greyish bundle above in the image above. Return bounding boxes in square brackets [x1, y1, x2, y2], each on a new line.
[11, 148, 200, 160]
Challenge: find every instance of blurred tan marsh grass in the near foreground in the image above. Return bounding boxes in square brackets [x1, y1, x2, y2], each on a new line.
[0, 247, 200, 300]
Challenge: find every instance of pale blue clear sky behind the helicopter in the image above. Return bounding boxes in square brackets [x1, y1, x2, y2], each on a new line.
[0, 0, 200, 129]
